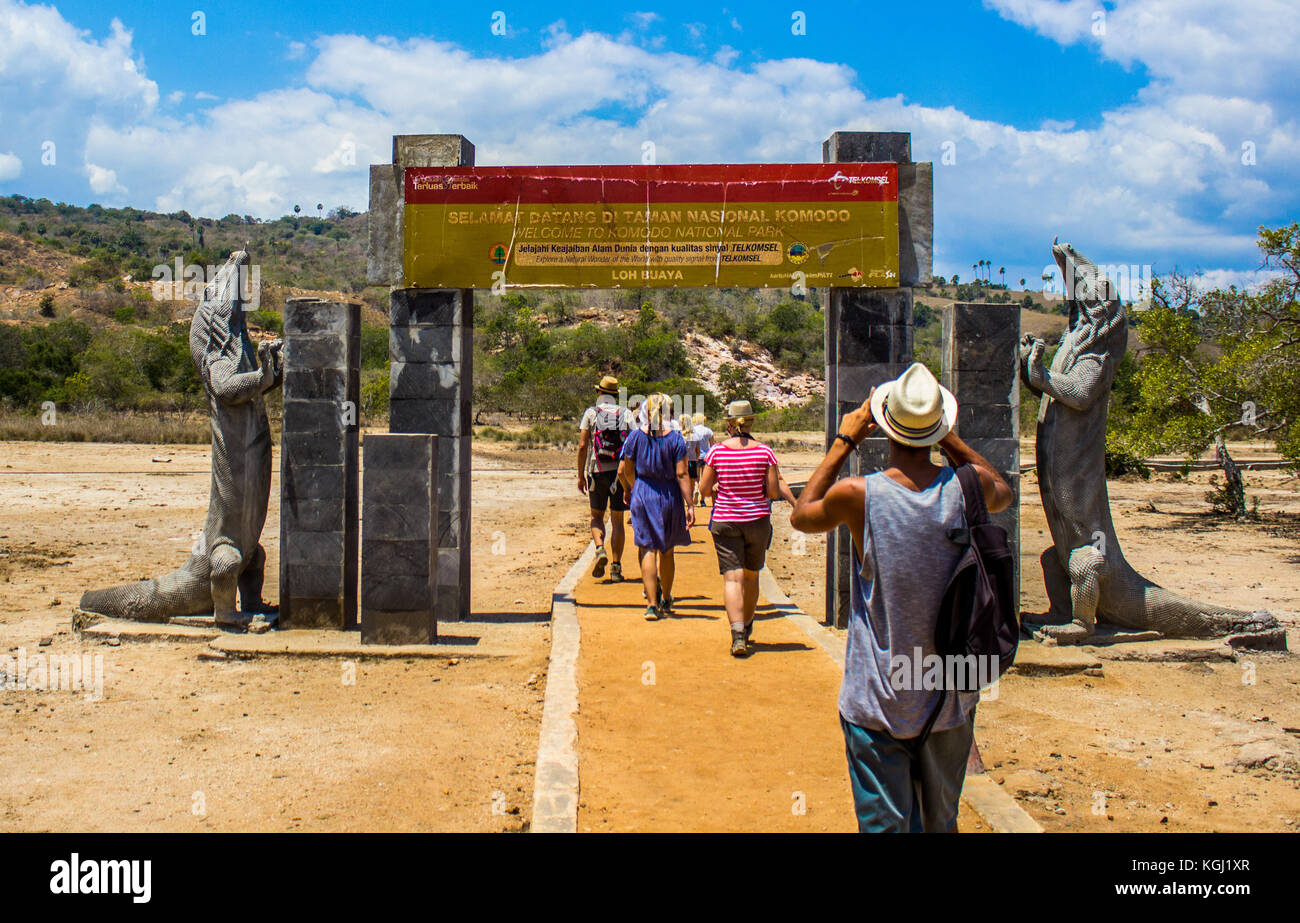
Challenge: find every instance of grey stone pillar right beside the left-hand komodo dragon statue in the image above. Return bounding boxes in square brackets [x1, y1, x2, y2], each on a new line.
[280, 298, 361, 629]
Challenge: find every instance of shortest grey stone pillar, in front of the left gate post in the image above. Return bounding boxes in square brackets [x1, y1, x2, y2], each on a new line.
[361, 433, 441, 645]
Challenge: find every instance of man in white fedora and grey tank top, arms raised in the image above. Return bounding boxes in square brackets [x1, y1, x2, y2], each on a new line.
[790, 363, 1014, 832]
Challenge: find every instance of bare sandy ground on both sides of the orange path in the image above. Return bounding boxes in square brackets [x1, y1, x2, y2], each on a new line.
[0, 443, 1300, 831]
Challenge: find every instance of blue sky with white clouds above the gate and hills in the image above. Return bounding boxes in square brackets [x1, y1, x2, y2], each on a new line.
[0, 0, 1300, 288]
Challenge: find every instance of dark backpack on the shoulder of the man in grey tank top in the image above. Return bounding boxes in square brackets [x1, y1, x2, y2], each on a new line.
[913, 464, 1021, 775]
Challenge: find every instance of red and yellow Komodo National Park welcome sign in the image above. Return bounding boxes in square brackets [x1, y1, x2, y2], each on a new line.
[403, 164, 898, 289]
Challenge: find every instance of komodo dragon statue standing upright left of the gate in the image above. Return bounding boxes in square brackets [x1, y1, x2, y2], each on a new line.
[79, 250, 283, 628]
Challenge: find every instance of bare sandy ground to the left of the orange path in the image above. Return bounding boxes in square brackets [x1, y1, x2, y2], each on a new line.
[0, 443, 588, 831]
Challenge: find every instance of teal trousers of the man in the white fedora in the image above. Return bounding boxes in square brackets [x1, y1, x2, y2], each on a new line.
[840, 709, 975, 833]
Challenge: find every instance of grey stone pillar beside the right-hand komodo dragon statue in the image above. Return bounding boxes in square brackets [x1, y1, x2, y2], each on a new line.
[943, 303, 1021, 599]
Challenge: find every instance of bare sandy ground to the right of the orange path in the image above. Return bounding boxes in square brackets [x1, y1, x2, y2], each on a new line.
[768, 442, 1300, 831]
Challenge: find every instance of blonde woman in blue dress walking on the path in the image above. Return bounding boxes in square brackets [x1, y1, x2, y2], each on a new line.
[619, 394, 696, 621]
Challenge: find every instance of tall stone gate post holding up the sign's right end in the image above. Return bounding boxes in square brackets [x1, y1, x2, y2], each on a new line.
[822, 131, 933, 628]
